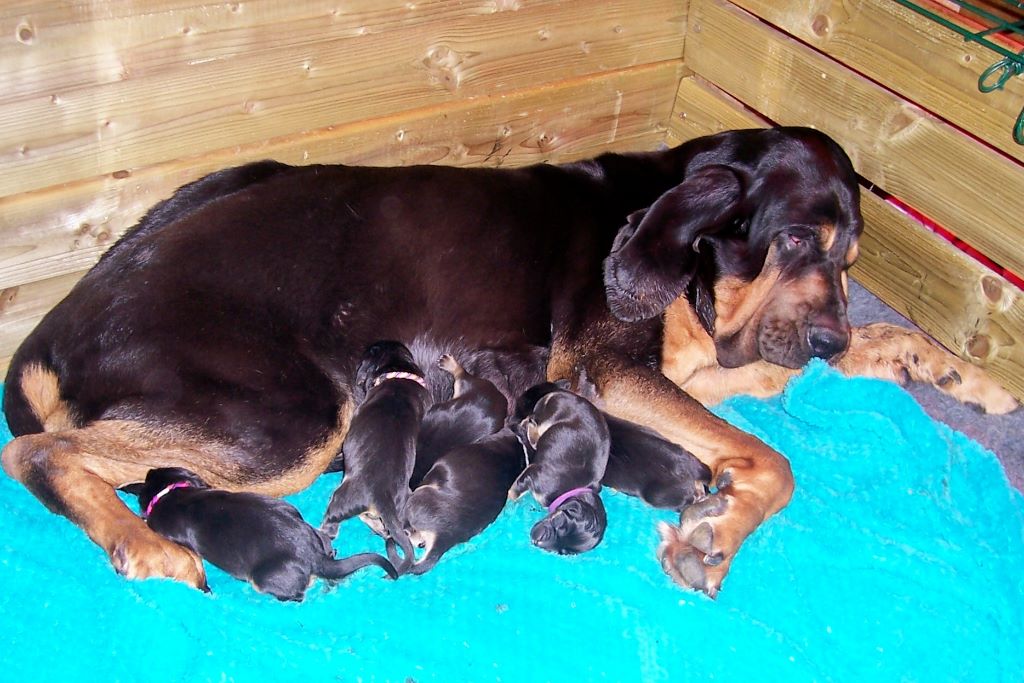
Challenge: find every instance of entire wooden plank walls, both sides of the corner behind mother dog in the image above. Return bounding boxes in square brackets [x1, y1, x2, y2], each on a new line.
[0, 0, 1024, 396]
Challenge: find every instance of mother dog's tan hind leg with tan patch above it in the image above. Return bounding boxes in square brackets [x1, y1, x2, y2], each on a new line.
[0, 371, 350, 588]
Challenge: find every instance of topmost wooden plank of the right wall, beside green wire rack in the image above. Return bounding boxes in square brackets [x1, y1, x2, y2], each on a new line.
[732, 0, 1024, 162]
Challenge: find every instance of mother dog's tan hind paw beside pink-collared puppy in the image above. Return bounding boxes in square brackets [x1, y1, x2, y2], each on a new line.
[110, 529, 210, 592]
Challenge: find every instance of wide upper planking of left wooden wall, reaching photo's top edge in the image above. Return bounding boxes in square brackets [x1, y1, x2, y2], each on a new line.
[0, 0, 683, 197]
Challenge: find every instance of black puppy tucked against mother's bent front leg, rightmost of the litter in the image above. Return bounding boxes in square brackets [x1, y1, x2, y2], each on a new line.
[601, 415, 711, 510]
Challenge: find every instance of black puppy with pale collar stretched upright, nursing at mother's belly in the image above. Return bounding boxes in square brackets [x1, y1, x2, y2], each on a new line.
[321, 341, 430, 563]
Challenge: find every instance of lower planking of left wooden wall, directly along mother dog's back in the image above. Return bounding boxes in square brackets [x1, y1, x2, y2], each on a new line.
[0, 62, 682, 367]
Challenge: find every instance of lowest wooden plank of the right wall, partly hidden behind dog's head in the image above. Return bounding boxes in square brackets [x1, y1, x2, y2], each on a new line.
[668, 78, 1024, 399]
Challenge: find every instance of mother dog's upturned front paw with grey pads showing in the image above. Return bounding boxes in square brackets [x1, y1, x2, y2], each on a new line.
[657, 494, 732, 598]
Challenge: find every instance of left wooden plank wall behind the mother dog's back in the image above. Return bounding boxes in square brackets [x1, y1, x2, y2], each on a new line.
[0, 0, 685, 369]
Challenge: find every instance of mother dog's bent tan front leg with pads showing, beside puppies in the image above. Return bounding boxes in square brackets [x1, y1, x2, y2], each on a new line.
[569, 354, 794, 596]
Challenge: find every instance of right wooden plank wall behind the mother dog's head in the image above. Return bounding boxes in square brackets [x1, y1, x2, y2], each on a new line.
[669, 0, 1024, 403]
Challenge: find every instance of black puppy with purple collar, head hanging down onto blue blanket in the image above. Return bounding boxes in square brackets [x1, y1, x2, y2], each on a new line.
[509, 383, 609, 554]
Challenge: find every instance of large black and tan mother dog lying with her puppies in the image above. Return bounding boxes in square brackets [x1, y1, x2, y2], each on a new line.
[3, 128, 1016, 595]
